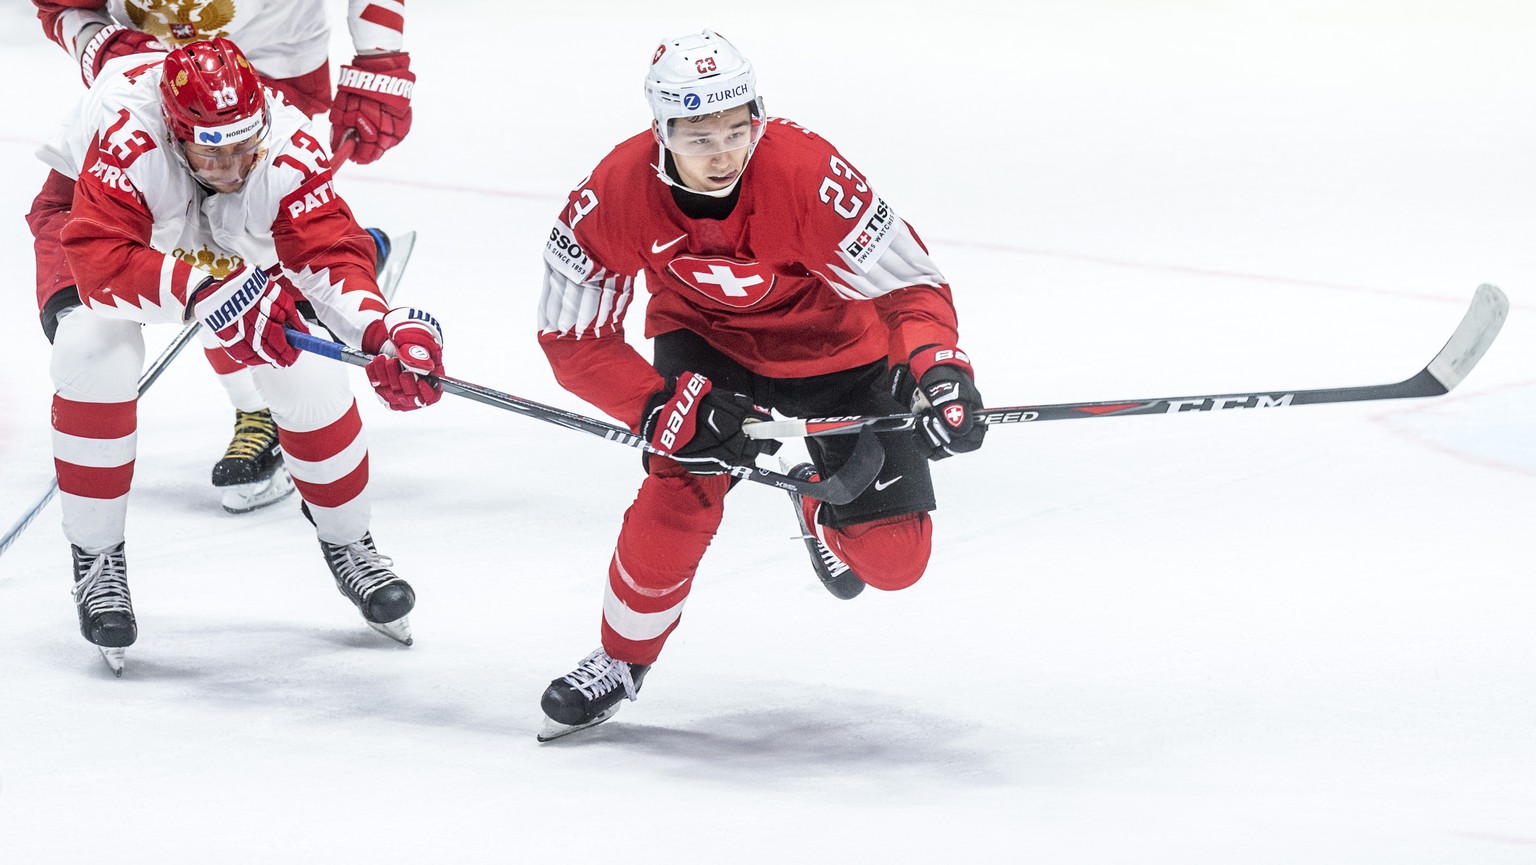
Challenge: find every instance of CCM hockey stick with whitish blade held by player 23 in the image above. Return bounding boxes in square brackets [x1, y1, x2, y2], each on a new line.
[746, 284, 1510, 438]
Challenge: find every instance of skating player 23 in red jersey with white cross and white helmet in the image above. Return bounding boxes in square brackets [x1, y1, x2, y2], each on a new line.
[539, 31, 985, 739]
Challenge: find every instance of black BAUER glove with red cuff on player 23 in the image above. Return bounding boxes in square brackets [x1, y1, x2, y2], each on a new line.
[641, 372, 779, 475]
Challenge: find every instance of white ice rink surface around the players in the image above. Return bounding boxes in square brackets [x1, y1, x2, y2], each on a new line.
[0, 0, 1536, 865]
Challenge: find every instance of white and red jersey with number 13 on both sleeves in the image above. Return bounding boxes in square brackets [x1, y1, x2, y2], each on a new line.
[38, 54, 387, 346]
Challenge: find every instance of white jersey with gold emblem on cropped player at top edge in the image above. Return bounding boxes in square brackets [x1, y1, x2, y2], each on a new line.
[34, 0, 406, 78]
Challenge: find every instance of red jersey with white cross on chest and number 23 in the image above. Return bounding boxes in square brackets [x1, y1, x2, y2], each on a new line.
[539, 118, 957, 427]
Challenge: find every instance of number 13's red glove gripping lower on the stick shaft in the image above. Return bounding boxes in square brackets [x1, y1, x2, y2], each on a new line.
[362, 306, 442, 412]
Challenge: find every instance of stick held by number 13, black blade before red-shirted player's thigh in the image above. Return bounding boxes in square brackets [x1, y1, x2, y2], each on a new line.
[287, 330, 885, 504]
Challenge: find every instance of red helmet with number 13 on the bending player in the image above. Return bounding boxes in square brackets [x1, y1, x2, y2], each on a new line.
[160, 38, 267, 146]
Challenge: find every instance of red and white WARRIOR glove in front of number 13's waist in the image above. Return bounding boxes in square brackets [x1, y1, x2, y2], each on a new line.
[186, 264, 309, 366]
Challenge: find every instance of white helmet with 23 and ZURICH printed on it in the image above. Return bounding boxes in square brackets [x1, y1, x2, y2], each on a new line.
[645, 31, 766, 149]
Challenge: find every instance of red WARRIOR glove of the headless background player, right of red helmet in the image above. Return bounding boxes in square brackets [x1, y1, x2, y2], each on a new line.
[330, 51, 416, 164]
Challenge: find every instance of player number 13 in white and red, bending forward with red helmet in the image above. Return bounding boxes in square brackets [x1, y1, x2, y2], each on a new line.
[38, 38, 442, 670]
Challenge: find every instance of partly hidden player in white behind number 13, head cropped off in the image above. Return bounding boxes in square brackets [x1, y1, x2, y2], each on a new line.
[32, 0, 416, 513]
